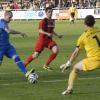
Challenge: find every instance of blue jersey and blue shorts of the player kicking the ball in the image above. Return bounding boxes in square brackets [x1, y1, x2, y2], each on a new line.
[0, 19, 16, 61]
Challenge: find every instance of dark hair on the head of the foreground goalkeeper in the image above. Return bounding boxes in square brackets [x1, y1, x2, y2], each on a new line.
[84, 15, 95, 27]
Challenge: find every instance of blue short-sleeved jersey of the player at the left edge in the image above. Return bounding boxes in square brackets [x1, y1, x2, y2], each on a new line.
[0, 19, 9, 46]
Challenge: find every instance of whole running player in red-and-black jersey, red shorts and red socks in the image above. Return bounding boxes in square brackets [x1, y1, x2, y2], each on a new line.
[24, 7, 62, 70]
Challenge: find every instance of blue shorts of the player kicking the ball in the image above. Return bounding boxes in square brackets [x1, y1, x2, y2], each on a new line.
[0, 45, 16, 61]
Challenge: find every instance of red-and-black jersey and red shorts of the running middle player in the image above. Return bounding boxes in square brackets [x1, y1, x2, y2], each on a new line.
[34, 18, 56, 52]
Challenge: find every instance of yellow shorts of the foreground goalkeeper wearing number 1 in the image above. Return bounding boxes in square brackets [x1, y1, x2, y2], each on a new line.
[83, 58, 100, 71]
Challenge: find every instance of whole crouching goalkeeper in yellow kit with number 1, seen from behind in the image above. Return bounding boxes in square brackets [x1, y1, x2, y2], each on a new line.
[60, 15, 100, 95]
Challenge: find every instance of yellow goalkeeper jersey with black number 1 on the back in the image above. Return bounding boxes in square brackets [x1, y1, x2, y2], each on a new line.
[77, 27, 100, 59]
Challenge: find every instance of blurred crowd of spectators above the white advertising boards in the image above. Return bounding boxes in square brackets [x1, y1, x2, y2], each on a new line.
[0, 0, 100, 10]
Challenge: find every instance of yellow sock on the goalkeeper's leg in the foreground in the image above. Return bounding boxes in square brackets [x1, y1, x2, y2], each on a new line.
[67, 69, 77, 90]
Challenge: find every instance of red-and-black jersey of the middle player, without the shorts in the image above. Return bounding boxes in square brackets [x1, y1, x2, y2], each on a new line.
[39, 18, 55, 40]
